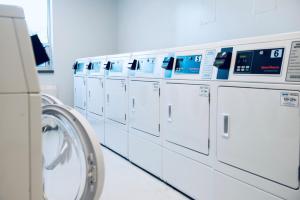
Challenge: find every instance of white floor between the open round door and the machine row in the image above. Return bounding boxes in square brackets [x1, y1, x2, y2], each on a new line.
[100, 147, 187, 200]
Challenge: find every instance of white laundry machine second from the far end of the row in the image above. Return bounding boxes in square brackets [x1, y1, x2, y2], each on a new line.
[86, 56, 106, 144]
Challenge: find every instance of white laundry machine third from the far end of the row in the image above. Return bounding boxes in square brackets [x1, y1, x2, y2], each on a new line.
[105, 54, 130, 158]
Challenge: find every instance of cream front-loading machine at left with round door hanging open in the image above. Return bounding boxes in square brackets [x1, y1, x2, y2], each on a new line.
[0, 5, 104, 200]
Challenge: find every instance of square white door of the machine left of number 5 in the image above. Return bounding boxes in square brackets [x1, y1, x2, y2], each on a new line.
[129, 81, 160, 136]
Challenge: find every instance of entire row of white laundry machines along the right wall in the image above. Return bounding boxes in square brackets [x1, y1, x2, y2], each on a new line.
[74, 32, 300, 200]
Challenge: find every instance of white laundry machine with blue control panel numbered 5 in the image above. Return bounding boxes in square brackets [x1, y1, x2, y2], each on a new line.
[160, 46, 217, 200]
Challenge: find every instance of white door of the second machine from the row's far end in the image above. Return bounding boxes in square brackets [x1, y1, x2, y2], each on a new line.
[87, 77, 104, 116]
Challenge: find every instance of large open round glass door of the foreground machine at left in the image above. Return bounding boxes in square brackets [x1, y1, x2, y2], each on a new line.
[42, 104, 104, 200]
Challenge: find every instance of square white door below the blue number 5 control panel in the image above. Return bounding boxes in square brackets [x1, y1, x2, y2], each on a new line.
[164, 83, 209, 155]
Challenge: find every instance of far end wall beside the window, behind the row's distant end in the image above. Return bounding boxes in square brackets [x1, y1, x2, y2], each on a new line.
[39, 0, 117, 105]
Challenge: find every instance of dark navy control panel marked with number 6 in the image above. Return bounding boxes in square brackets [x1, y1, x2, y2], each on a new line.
[234, 48, 284, 74]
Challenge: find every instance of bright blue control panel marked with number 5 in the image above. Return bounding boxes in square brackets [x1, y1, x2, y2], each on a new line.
[175, 55, 202, 74]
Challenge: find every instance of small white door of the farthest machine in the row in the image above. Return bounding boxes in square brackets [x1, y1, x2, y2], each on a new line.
[74, 76, 86, 109]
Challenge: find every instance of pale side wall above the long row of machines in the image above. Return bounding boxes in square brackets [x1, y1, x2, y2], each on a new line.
[118, 0, 300, 52]
